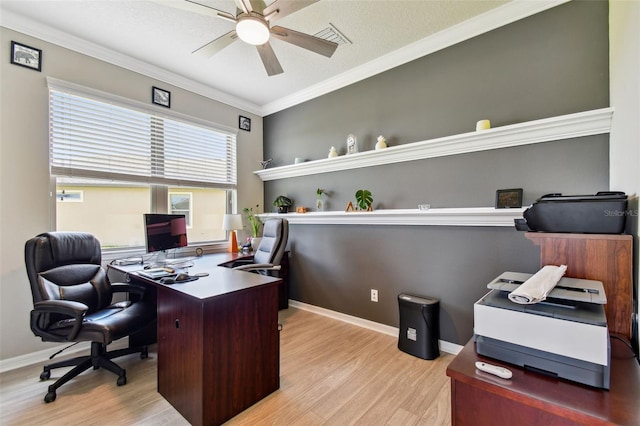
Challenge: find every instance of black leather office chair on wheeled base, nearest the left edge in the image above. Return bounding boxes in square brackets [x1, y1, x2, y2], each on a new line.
[25, 232, 156, 402]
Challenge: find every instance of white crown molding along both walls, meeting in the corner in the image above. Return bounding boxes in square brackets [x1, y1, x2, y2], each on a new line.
[0, 0, 570, 117]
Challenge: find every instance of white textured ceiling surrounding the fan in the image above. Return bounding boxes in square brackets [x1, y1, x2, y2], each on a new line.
[1, 0, 540, 114]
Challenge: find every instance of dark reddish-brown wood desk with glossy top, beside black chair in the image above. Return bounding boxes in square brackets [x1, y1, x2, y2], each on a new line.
[111, 254, 281, 425]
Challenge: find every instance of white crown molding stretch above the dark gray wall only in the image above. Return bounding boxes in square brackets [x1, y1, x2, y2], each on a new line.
[261, 0, 570, 116]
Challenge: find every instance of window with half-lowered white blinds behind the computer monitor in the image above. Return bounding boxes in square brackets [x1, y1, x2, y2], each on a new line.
[48, 78, 236, 248]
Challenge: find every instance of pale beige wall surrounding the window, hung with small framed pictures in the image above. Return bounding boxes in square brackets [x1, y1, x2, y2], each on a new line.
[0, 28, 263, 360]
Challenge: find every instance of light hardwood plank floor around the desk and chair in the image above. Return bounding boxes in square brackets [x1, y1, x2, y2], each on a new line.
[0, 308, 453, 426]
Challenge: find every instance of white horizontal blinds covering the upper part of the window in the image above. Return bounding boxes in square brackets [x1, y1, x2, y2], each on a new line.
[49, 81, 237, 189]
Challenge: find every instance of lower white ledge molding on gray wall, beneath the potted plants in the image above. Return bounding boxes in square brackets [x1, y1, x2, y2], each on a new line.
[258, 207, 526, 227]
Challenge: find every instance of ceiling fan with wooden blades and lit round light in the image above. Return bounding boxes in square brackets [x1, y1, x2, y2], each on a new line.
[165, 0, 338, 76]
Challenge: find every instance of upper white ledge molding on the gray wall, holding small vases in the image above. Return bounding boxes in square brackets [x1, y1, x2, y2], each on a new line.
[253, 108, 613, 181]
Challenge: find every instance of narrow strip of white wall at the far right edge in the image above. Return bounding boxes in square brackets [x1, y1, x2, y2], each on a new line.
[609, 0, 640, 346]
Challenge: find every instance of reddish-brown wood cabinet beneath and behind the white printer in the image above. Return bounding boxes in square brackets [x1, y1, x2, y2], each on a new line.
[447, 232, 640, 426]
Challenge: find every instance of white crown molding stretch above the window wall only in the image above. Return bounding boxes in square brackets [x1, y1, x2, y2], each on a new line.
[0, 10, 261, 115]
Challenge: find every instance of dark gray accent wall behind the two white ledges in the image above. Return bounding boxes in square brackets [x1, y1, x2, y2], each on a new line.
[264, 1, 615, 344]
